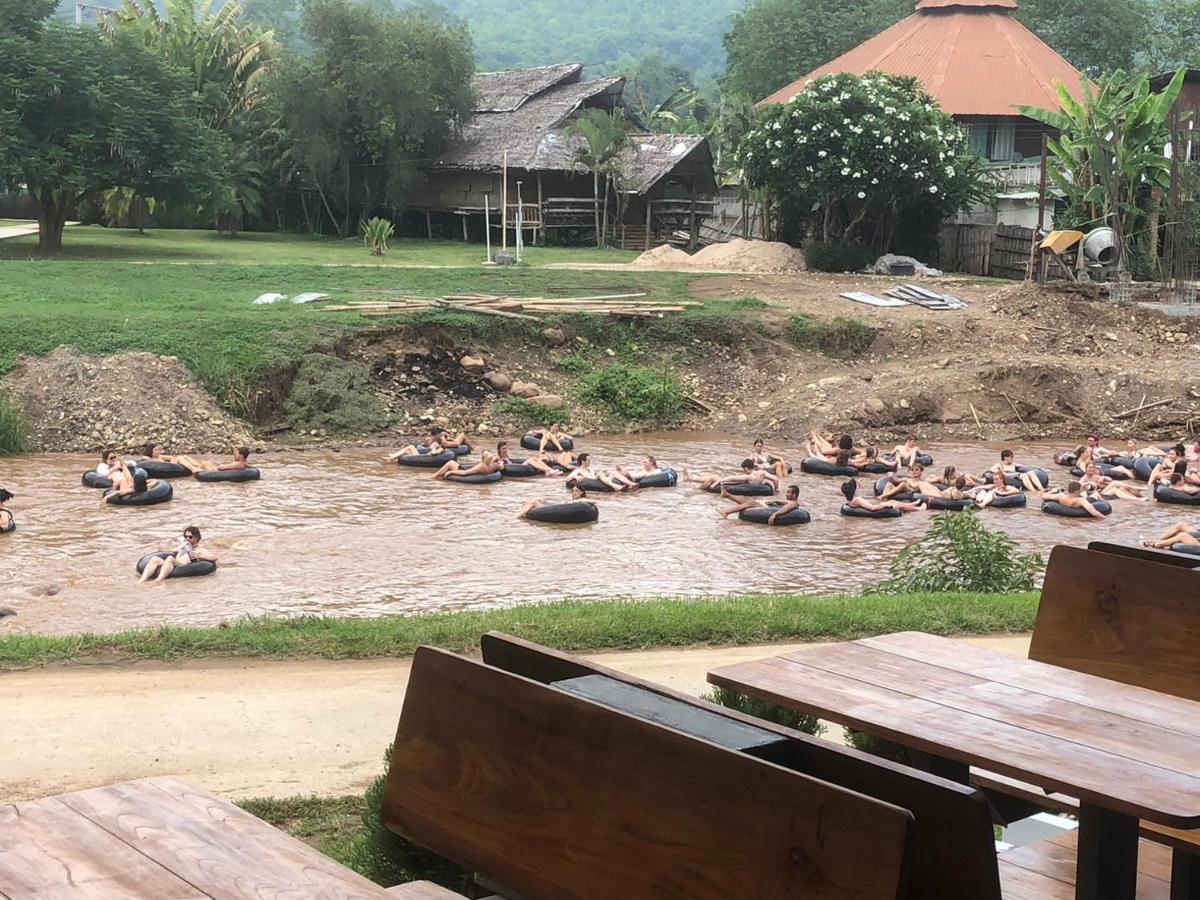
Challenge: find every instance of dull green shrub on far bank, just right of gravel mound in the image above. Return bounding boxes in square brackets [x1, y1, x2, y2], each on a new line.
[283, 353, 386, 434]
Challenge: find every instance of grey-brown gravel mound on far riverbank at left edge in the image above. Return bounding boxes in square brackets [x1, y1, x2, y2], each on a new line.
[2, 347, 254, 452]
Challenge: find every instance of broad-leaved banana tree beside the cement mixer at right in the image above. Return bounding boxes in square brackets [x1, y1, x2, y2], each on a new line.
[1019, 70, 1184, 269]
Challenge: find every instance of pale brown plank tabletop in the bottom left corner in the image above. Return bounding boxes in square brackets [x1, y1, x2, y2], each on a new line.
[0, 778, 390, 900]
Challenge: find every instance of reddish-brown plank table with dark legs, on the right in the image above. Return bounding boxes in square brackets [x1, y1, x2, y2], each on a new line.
[708, 632, 1200, 900]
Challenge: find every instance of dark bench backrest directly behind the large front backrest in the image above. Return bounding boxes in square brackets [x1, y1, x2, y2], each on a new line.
[481, 632, 1000, 900]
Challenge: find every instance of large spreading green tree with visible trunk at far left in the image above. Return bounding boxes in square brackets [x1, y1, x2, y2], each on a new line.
[0, 0, 220, 253]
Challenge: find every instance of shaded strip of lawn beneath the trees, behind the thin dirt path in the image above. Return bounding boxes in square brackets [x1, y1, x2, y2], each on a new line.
[0, 220, 637, 269]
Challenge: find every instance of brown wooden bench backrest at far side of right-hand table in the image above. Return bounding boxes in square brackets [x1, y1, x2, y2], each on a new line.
[1030, 546, 1200, 700]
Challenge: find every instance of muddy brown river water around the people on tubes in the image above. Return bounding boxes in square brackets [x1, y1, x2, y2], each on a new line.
[0, 433, 1190, 634]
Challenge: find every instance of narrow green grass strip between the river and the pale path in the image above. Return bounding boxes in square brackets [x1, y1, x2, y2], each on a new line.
[0, 593, 1037, 668]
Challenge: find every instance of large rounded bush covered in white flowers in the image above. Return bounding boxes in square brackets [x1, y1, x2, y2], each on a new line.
[738, 72, 988, 250]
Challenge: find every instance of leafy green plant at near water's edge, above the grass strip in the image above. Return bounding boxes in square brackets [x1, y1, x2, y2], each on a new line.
[868, 509, 1045, 594]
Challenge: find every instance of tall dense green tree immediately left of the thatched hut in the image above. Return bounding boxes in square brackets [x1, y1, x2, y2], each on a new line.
[276, 0, 475, 235]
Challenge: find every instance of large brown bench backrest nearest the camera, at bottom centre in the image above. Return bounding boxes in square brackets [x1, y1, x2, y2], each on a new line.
[383, 648, 912, 900]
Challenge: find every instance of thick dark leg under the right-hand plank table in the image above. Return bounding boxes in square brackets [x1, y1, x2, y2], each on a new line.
[1075, 803, 1138, 900]
